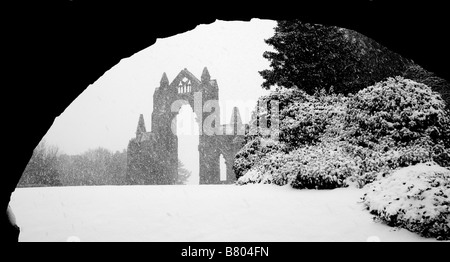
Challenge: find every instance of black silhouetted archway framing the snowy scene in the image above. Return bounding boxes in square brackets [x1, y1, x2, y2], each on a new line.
[0, 1, 450, 244]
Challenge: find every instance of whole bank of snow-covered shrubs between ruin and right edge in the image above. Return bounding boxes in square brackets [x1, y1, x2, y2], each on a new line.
[233, 77, 450, 189]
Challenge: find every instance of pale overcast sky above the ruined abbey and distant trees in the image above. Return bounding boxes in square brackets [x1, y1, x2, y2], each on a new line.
[44, 19, 276, 182]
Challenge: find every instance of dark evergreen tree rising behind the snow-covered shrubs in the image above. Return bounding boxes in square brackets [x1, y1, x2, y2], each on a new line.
[259, 20, 412, 94]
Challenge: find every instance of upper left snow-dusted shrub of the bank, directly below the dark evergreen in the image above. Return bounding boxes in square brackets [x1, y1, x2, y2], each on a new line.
[247, 88, 346, 149]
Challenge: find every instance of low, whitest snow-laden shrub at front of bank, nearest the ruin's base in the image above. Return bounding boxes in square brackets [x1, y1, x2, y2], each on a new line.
[238, 143, 359, 189]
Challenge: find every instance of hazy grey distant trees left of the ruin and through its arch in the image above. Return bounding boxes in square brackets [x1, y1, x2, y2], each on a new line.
[17, 140, 191, 187]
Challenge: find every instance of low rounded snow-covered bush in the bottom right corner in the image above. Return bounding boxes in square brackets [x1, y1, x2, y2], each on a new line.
[363, 163, 450, 240]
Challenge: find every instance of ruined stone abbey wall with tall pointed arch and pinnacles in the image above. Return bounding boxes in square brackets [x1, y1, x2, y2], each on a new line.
[127, 67, 244, 184]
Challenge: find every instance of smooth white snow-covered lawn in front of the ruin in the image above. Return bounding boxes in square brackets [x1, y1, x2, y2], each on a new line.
[10, 185, 436, 242]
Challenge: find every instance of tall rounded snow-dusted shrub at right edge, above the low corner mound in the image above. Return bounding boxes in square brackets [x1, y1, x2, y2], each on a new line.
[345, 77, 450, 166]
